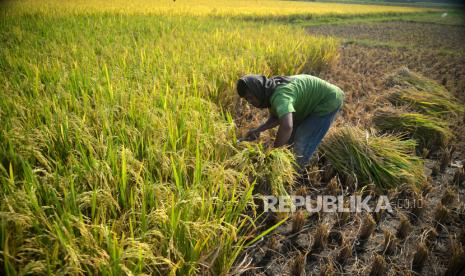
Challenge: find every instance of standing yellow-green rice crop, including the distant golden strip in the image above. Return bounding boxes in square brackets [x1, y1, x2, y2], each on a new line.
[0, 0, 446, 275]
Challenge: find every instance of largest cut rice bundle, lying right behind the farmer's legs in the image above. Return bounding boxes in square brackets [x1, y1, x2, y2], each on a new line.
[320, 127, 426, 190]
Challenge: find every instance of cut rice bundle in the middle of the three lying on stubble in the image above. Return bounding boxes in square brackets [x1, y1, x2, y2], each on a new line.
[373, 110, 452, 152]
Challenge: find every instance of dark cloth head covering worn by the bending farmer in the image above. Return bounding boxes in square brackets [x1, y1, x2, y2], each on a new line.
[237, 75, 293, 108]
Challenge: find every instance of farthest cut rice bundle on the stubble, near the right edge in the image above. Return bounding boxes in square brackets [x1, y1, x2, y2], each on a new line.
[386, 68, 464, 118]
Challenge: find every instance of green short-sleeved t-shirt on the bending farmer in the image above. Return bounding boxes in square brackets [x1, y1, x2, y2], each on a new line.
[270, 75, 344, 123]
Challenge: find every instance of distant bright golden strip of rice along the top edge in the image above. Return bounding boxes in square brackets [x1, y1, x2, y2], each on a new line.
[4, 0, 437, 18]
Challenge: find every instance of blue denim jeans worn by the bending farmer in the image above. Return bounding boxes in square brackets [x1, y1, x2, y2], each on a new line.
[293, 109, 339, 170]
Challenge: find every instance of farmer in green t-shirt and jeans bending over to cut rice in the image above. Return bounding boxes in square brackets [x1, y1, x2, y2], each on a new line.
[237, 75, 344, 170]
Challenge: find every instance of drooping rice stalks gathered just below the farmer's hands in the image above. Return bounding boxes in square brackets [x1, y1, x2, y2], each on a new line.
[229, 144, 296, 196]
